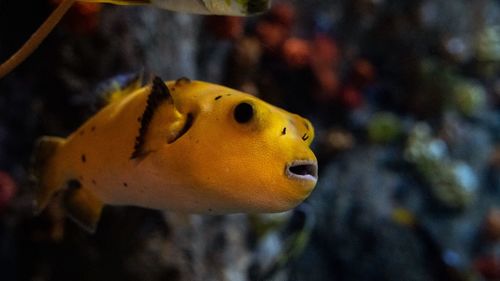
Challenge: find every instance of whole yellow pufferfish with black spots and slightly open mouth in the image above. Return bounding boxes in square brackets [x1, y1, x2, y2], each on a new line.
[34, 77, 318, 232]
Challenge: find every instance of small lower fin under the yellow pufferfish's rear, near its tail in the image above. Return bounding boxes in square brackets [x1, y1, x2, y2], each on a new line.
[63, 181, 103, 233]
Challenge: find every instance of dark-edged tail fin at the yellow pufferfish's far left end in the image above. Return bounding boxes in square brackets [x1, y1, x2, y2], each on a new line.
[32, 137, 65, 214]
